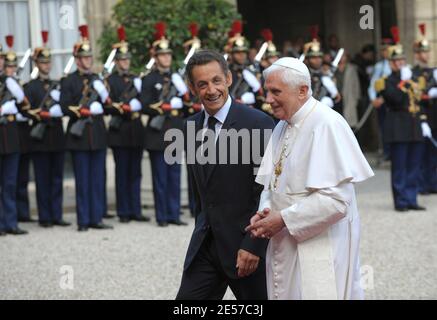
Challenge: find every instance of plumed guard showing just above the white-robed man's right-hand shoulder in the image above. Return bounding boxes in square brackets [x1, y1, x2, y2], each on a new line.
[304, 26, 341, 108]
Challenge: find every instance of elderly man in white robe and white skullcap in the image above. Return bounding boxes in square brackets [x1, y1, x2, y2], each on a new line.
[246, 58, 373, 300]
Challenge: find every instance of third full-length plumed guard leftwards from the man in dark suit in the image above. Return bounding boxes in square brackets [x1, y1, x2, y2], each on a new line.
[60, 26, 112, 231]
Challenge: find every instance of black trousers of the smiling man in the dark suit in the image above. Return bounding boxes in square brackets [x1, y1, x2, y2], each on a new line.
[176, 231, 267, 300]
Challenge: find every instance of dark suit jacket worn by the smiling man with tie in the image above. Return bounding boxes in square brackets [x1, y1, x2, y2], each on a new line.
[184, 102, 274, 279]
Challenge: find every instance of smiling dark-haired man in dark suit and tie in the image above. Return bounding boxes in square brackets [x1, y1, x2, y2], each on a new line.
[177, 50, 274, 300]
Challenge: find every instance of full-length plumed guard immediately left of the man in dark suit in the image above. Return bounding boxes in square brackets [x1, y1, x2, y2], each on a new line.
[141, 22, 189, 227]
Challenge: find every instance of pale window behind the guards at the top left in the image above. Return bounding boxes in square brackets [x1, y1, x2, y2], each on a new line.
[0, 0, 84, 81]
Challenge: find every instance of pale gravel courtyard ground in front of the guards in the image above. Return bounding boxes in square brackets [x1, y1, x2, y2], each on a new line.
[0, 161, 437, 299]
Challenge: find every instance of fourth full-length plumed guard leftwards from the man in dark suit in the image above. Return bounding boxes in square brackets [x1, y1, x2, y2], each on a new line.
[24, 31, 70, 228]
